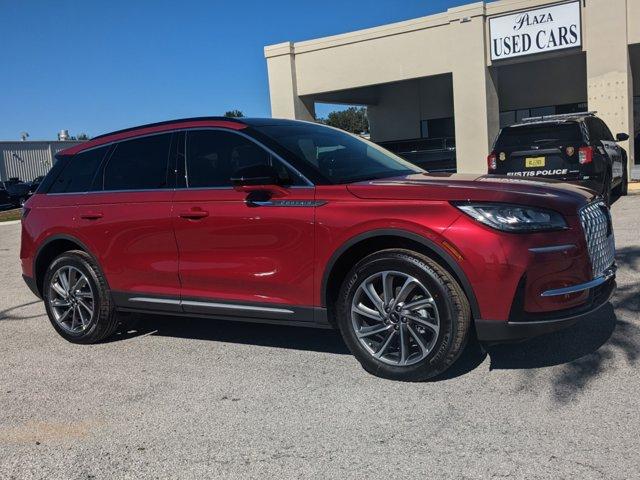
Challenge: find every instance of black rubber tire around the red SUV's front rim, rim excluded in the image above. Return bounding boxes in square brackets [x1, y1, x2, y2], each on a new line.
[338, 252, 458, 380]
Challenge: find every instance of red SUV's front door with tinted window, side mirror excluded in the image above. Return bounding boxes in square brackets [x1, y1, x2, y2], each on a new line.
[173, 129, 315, 322]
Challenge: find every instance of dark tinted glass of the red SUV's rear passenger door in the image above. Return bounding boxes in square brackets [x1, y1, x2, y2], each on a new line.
[103, 133, 172, 190]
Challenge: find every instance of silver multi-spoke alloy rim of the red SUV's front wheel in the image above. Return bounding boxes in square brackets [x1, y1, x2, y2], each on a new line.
[351, 271, 440, 366]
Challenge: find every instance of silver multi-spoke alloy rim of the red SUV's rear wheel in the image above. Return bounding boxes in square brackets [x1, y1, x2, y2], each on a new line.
[48, 265, 95, 333]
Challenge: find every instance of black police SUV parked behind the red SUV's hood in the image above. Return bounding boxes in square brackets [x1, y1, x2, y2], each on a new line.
[487, 112, 629, 203]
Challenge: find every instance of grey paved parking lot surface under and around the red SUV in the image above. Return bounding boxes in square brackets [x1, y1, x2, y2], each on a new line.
[0, 195, 640, 479]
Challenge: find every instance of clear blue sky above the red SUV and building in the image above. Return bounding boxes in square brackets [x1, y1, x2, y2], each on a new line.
[0, 0, 476, 140]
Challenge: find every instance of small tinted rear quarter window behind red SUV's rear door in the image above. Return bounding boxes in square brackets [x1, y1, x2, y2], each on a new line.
[49, 147, 109, 193]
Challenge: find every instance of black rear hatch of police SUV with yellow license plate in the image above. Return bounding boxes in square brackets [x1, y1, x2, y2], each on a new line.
[489, 121, 584, 180]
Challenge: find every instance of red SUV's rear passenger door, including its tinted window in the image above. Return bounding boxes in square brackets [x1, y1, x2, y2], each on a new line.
[78, 133, 181, 311]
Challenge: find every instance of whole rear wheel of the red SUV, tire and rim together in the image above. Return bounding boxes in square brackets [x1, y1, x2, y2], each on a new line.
[42, 250, 118, 344]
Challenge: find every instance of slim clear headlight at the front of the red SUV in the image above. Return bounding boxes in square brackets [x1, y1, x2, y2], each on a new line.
[455, 203, 567, 232]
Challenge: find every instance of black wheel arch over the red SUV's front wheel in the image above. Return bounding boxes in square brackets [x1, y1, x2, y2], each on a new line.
[320, 229, 480, 326]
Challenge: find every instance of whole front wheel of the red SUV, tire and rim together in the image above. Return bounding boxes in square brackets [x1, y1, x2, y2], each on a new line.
[336, 249, 471, 382]
